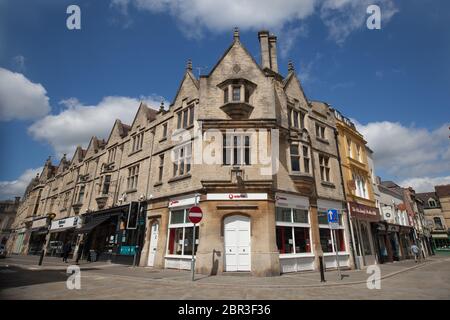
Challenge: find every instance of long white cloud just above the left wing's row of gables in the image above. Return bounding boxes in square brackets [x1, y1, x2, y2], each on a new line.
[28, 96, 161, 156]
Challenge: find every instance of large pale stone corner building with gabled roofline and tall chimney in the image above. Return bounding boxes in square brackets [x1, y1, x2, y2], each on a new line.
[9, 30, 354, 276]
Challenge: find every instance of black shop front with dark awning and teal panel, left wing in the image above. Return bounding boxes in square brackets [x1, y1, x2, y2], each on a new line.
[74, 202, 145, 265]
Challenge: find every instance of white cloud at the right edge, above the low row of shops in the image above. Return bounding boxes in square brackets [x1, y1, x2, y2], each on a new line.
[356, 121, 450, 180]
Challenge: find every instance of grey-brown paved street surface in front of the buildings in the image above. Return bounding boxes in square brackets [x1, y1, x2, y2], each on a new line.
[0, 252, 450, 300]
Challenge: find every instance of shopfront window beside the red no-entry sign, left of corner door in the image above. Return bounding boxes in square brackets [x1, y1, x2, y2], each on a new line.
[168, 209, 199, 255]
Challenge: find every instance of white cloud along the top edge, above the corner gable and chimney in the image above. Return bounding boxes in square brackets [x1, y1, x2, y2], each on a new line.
[111, 0, 397, 46]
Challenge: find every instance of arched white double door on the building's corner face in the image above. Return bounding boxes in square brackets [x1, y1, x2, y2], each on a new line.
[224, 215, 251, 271]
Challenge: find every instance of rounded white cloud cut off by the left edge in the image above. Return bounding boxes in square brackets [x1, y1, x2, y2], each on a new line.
[0, 68, 50, 121]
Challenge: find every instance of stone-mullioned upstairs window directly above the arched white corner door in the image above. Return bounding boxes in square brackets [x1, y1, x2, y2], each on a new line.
[222, 134, 251, 165]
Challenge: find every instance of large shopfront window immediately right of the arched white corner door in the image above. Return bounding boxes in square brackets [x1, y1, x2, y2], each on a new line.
[275, 207, 311, 254]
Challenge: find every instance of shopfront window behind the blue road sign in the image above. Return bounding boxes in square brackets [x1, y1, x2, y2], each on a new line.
[318, 210, 346, 253]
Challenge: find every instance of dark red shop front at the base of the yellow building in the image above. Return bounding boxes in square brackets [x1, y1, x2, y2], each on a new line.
[348, 202, 381, 269]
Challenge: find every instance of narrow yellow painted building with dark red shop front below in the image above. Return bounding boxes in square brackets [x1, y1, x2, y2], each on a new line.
[334, 110, 380, 267]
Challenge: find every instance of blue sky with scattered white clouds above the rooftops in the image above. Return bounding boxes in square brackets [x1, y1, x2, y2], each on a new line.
[0, 0, 450, 198]
